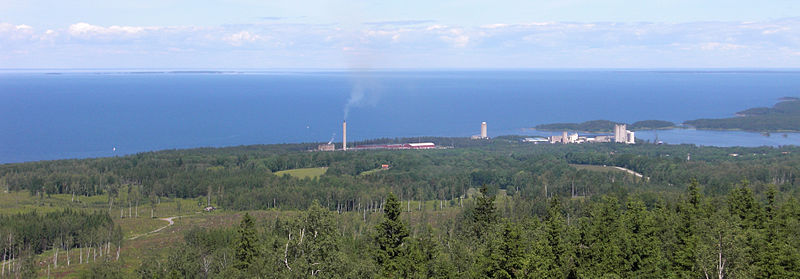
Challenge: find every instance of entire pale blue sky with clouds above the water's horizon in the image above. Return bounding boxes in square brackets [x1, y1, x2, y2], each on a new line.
[0, 0, 800, 69]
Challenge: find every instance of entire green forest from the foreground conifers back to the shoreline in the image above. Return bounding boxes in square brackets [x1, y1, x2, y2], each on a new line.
[0, 136, 800, 278]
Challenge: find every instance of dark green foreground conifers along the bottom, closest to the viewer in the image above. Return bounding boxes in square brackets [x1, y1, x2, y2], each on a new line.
[128, 181, 800, 278]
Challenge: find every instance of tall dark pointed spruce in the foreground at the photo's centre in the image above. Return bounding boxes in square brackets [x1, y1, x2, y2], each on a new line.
[375, 193, 408, 278]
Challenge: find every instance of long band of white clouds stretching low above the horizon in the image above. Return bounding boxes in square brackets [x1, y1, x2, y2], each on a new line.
[0, 18, 800, 67]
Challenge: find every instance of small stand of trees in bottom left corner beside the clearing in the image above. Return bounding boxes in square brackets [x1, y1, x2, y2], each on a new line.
[0, 209, 122, 277]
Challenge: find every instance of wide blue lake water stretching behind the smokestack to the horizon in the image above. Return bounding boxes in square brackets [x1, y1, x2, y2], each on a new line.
[0, 70, 800, 163]
